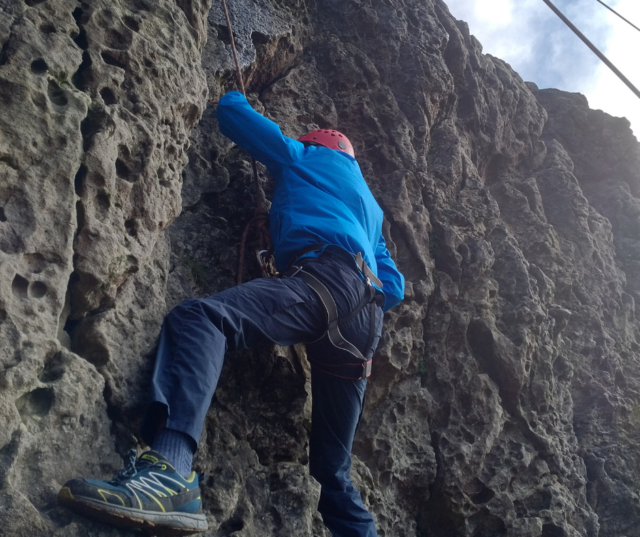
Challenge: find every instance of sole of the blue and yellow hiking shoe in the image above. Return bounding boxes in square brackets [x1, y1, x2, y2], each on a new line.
[58, 487, 208, 537]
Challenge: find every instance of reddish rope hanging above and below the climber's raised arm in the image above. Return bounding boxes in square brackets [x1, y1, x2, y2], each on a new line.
[222, 0, 273, 285]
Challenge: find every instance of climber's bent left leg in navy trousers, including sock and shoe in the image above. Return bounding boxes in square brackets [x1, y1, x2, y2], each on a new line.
[58, 279, 326, 536]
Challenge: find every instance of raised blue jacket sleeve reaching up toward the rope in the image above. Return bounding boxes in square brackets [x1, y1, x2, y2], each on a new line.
[217, 91, 303, 179]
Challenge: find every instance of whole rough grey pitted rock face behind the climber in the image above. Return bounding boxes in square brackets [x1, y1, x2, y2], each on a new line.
[0, 0, 640, 537]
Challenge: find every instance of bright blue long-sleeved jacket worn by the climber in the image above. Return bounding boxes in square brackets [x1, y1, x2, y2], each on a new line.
[218, 91, 404, 311]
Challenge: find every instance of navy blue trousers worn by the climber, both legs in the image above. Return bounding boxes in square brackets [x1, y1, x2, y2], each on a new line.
[142, 252, 383, 537]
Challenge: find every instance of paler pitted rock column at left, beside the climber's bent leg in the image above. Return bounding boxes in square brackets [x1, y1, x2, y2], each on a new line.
[0, 0, 208, 536]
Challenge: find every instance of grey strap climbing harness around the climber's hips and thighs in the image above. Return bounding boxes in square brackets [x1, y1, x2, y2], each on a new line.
[285, 244, 383, 380]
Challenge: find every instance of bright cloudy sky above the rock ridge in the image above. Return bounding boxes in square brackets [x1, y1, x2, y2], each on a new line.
[445, 0, 640, 139]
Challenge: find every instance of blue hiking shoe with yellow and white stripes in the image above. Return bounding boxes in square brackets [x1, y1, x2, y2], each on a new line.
[58, 450, 207, 536]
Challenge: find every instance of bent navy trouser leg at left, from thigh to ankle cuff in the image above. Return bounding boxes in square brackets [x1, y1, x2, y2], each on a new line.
[141, 278, 326, 449]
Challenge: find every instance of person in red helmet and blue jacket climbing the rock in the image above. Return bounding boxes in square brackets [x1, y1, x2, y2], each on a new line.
[58, 91, 404, 537]
